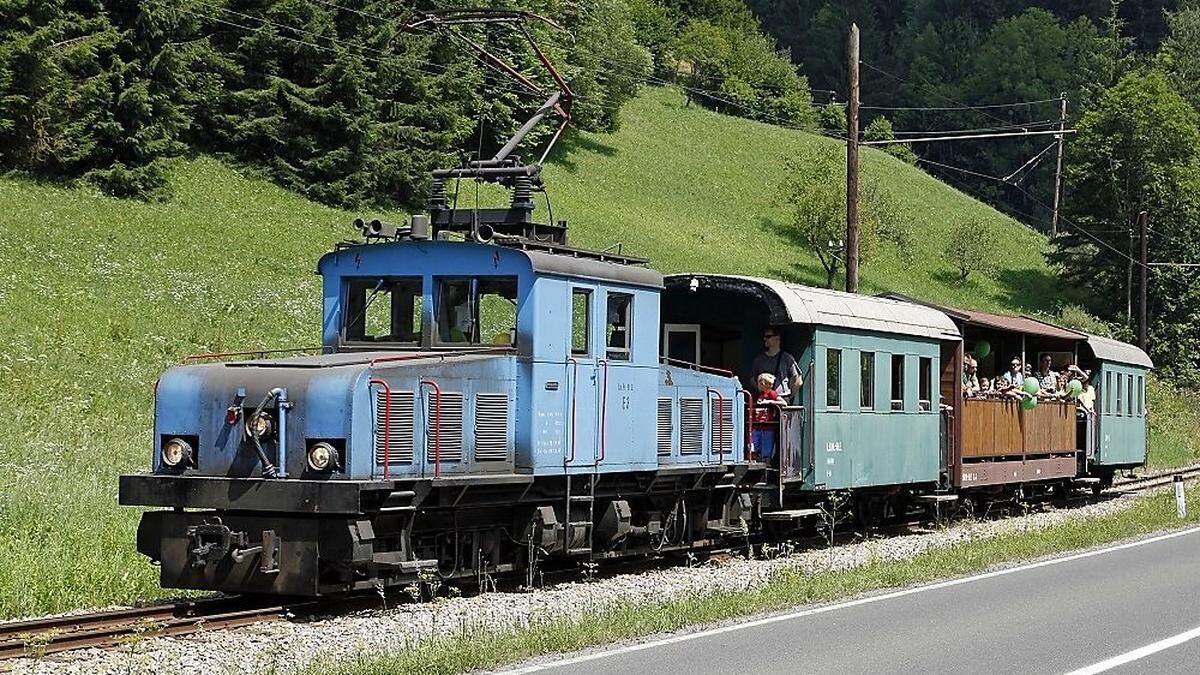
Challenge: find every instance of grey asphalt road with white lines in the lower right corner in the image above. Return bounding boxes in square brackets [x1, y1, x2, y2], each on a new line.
[501, 528, 1200, 675]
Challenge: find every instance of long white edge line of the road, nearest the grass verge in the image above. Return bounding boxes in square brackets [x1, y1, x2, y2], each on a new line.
[500, 527, 1200, 675]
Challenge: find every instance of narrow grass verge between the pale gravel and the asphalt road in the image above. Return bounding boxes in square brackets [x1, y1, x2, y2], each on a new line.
[314, 486, 1200, 675]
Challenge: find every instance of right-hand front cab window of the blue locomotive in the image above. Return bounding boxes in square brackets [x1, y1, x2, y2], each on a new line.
[434, 276, 517, 346]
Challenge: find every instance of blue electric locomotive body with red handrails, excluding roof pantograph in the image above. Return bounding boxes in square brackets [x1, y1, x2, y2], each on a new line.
[121, 214, 752, 595]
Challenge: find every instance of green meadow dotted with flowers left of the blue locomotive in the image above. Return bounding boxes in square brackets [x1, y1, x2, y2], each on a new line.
[0, 160, 350, 616]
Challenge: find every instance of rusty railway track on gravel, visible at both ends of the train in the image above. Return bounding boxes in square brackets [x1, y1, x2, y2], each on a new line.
[0, 465, 1200, 661]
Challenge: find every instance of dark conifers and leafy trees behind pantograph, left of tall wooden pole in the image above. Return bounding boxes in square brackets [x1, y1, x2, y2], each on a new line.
[0, 0, 815, 205]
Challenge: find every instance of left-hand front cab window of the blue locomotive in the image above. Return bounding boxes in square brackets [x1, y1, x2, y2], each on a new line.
[342, 276, 425, 345]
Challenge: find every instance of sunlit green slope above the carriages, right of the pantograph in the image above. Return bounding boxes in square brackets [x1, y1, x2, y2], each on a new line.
[546, 89, 1058, 311]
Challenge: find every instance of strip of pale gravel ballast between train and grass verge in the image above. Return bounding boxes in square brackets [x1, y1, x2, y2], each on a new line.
[9, 497, 1152, 674]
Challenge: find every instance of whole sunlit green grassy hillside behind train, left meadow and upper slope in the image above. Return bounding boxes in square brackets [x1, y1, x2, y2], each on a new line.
[0, 86, 1196, 616]
